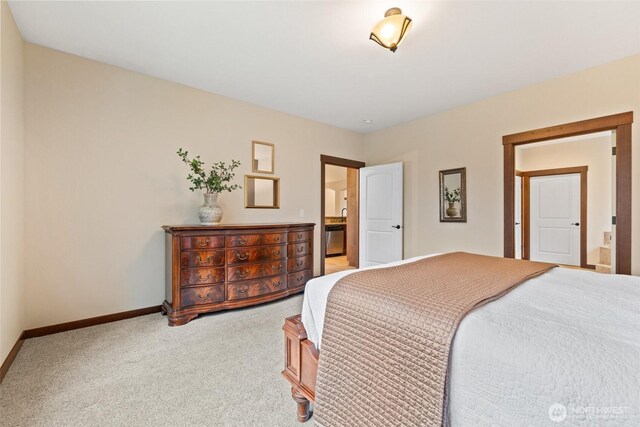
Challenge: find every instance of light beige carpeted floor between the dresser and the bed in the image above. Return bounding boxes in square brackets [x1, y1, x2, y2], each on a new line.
[0, 295, 302, 427]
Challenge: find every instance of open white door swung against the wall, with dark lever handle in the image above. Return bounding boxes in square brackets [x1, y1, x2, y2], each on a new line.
[360, 163, 403, 268]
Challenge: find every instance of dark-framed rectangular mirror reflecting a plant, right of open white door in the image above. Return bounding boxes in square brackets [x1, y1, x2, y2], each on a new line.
[440, 168, 467, 222]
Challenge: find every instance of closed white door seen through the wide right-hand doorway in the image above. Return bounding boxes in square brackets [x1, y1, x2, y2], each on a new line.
[530, 174, 580, 266]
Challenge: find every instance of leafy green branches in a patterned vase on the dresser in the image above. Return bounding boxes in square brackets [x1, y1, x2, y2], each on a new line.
[177, 148, 242, 225]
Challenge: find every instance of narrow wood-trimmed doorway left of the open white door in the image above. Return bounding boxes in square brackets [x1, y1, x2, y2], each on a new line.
[320, 155, 365, 276]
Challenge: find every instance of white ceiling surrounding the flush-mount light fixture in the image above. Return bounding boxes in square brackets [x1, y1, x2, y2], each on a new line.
[9, 0, 640, 133]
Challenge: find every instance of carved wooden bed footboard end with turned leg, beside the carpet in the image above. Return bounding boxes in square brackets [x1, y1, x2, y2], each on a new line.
[282, 315, 319, 422]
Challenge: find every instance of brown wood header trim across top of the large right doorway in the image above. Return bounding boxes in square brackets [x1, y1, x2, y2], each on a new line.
[502, 111, 633, 145]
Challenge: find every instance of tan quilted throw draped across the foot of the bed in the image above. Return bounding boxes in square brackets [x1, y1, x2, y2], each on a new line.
[314, 252, 554, 427]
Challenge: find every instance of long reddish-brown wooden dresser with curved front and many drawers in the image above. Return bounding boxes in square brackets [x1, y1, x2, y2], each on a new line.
[162, 223, 315, 326]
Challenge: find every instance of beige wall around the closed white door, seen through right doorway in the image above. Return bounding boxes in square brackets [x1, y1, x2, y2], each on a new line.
[516, 137, 612, 265]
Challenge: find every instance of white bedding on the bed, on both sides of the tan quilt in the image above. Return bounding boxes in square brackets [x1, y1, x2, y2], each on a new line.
[302, 257, 640, 426]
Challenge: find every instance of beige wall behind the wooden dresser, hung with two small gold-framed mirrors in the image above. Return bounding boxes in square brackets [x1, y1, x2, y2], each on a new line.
[25, 44, 364, 328]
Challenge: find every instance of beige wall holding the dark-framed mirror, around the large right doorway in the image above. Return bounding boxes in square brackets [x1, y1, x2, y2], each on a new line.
[365, 55, 640, 275]
